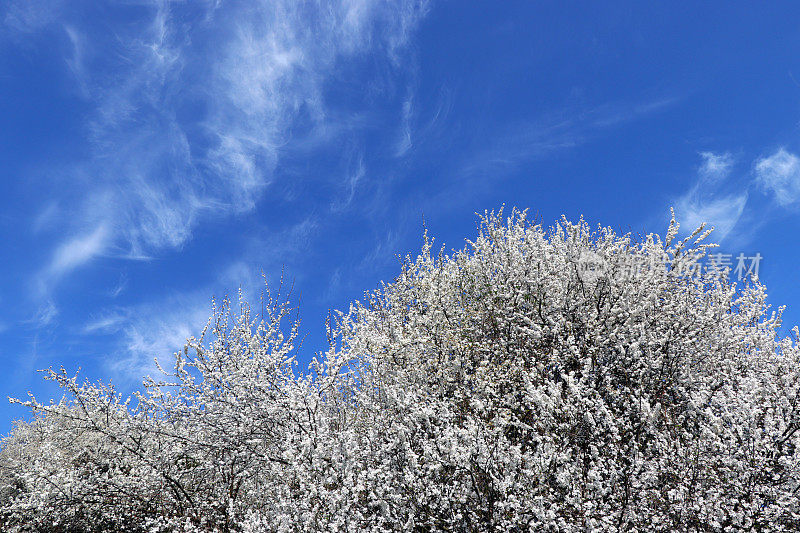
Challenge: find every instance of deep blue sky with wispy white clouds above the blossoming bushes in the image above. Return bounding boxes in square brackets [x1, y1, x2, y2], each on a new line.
[0, 0, 800, 433]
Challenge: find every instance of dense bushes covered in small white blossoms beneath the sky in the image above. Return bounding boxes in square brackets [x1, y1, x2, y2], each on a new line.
[0, 211, 800, 532]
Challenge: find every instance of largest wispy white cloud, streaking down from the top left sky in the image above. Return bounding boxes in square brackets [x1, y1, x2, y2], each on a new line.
[3, 0, 427, 284]
